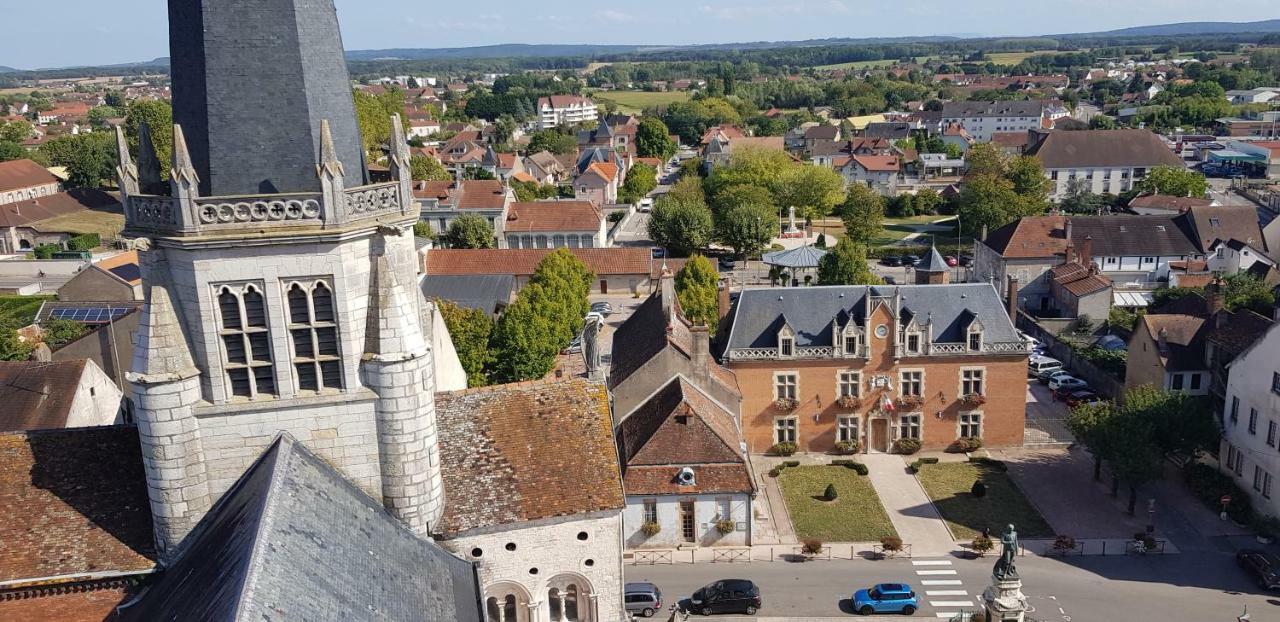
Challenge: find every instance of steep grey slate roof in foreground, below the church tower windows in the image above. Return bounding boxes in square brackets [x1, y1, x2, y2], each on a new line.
[120, 434, 481, 622]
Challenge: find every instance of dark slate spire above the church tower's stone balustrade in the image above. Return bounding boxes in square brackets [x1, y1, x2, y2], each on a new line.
[169, 0, 367, 196]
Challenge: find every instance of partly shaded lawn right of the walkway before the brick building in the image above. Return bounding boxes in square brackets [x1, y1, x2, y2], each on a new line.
[918, 462, 1053, 540]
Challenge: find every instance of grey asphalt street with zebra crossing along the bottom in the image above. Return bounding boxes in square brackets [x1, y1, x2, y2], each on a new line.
[625, 552, 1280, 622]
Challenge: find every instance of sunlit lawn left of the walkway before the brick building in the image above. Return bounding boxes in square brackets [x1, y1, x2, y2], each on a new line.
[778, 466, 897, 543]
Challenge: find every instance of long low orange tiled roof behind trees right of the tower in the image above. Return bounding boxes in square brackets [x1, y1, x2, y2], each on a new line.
[422, 247, 684, 295]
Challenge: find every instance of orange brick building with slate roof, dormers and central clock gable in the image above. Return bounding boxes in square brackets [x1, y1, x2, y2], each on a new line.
[722, 283, 1027, 453]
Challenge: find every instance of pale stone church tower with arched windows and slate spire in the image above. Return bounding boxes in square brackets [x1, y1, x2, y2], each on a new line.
[118, 0, 444, 555]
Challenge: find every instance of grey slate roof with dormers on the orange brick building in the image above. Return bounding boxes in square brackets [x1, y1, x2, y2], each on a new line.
[727, 283, 1019, 349]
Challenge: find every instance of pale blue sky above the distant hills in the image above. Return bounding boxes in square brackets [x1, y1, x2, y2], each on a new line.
[0, 0, 1277, 69]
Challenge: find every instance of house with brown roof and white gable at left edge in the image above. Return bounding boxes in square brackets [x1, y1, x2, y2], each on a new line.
[0, 358, 125, 431]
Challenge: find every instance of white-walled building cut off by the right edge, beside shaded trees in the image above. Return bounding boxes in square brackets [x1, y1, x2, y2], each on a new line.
[1219, 325, 1280, 517]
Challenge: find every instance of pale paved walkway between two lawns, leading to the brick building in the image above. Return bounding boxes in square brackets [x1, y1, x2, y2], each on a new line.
[860, 453, 956, 557]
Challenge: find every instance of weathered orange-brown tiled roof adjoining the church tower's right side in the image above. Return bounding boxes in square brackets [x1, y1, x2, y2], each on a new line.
[435, 379, 623, 538]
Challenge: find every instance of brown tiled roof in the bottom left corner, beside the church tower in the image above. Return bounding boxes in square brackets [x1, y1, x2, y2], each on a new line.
[0, 425, 156, 622]
